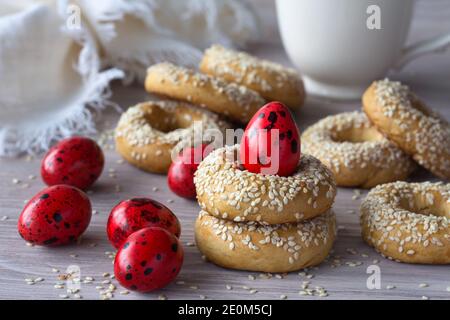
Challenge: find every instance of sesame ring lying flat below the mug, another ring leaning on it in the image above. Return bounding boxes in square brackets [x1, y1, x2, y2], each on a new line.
[302, 111, 415, 188]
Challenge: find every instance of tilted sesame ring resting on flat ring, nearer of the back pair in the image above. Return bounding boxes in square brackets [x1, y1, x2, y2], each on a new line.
[145, 63, 265, 123]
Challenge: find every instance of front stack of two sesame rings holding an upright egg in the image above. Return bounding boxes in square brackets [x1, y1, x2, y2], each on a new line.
[195, 145, 336, 273]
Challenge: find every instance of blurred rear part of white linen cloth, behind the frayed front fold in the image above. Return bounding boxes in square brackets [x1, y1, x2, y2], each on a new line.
[78, 0, 259, 80]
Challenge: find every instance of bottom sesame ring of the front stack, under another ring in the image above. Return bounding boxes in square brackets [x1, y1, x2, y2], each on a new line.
[195, 210, 336, 273]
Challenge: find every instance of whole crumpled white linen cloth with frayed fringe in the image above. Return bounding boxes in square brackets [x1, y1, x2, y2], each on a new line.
[0, 0, 258, 156]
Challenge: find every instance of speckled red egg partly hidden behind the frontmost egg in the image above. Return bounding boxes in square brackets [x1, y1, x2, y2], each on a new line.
[106, 198, 181, 248]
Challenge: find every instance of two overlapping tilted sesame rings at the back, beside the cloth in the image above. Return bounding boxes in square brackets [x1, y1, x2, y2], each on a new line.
[145, 45, 305, 124]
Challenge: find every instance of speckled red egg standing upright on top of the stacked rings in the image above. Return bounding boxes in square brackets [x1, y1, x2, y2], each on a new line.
[240, 102, 300, 176]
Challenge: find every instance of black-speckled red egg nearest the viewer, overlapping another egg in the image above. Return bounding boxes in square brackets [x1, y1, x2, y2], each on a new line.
[114, 228, 184, 292]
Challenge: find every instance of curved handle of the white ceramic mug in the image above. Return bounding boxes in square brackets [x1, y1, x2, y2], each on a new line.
[394, 33, 450, 70]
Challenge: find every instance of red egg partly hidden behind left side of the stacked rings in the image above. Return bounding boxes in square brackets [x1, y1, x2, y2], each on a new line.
[167, 144, 212, 199]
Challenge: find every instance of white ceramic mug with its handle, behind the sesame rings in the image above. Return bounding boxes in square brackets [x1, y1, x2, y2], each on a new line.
[276, 0, 450, 99]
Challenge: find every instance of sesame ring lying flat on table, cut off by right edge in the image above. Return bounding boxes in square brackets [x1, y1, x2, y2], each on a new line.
[361, 182, 450, 264]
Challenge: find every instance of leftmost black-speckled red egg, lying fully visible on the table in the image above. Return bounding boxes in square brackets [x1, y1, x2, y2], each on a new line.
[17, 185, 92, 246]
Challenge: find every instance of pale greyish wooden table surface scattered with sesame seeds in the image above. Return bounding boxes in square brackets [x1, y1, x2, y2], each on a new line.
[0, 0, 450, 299]
